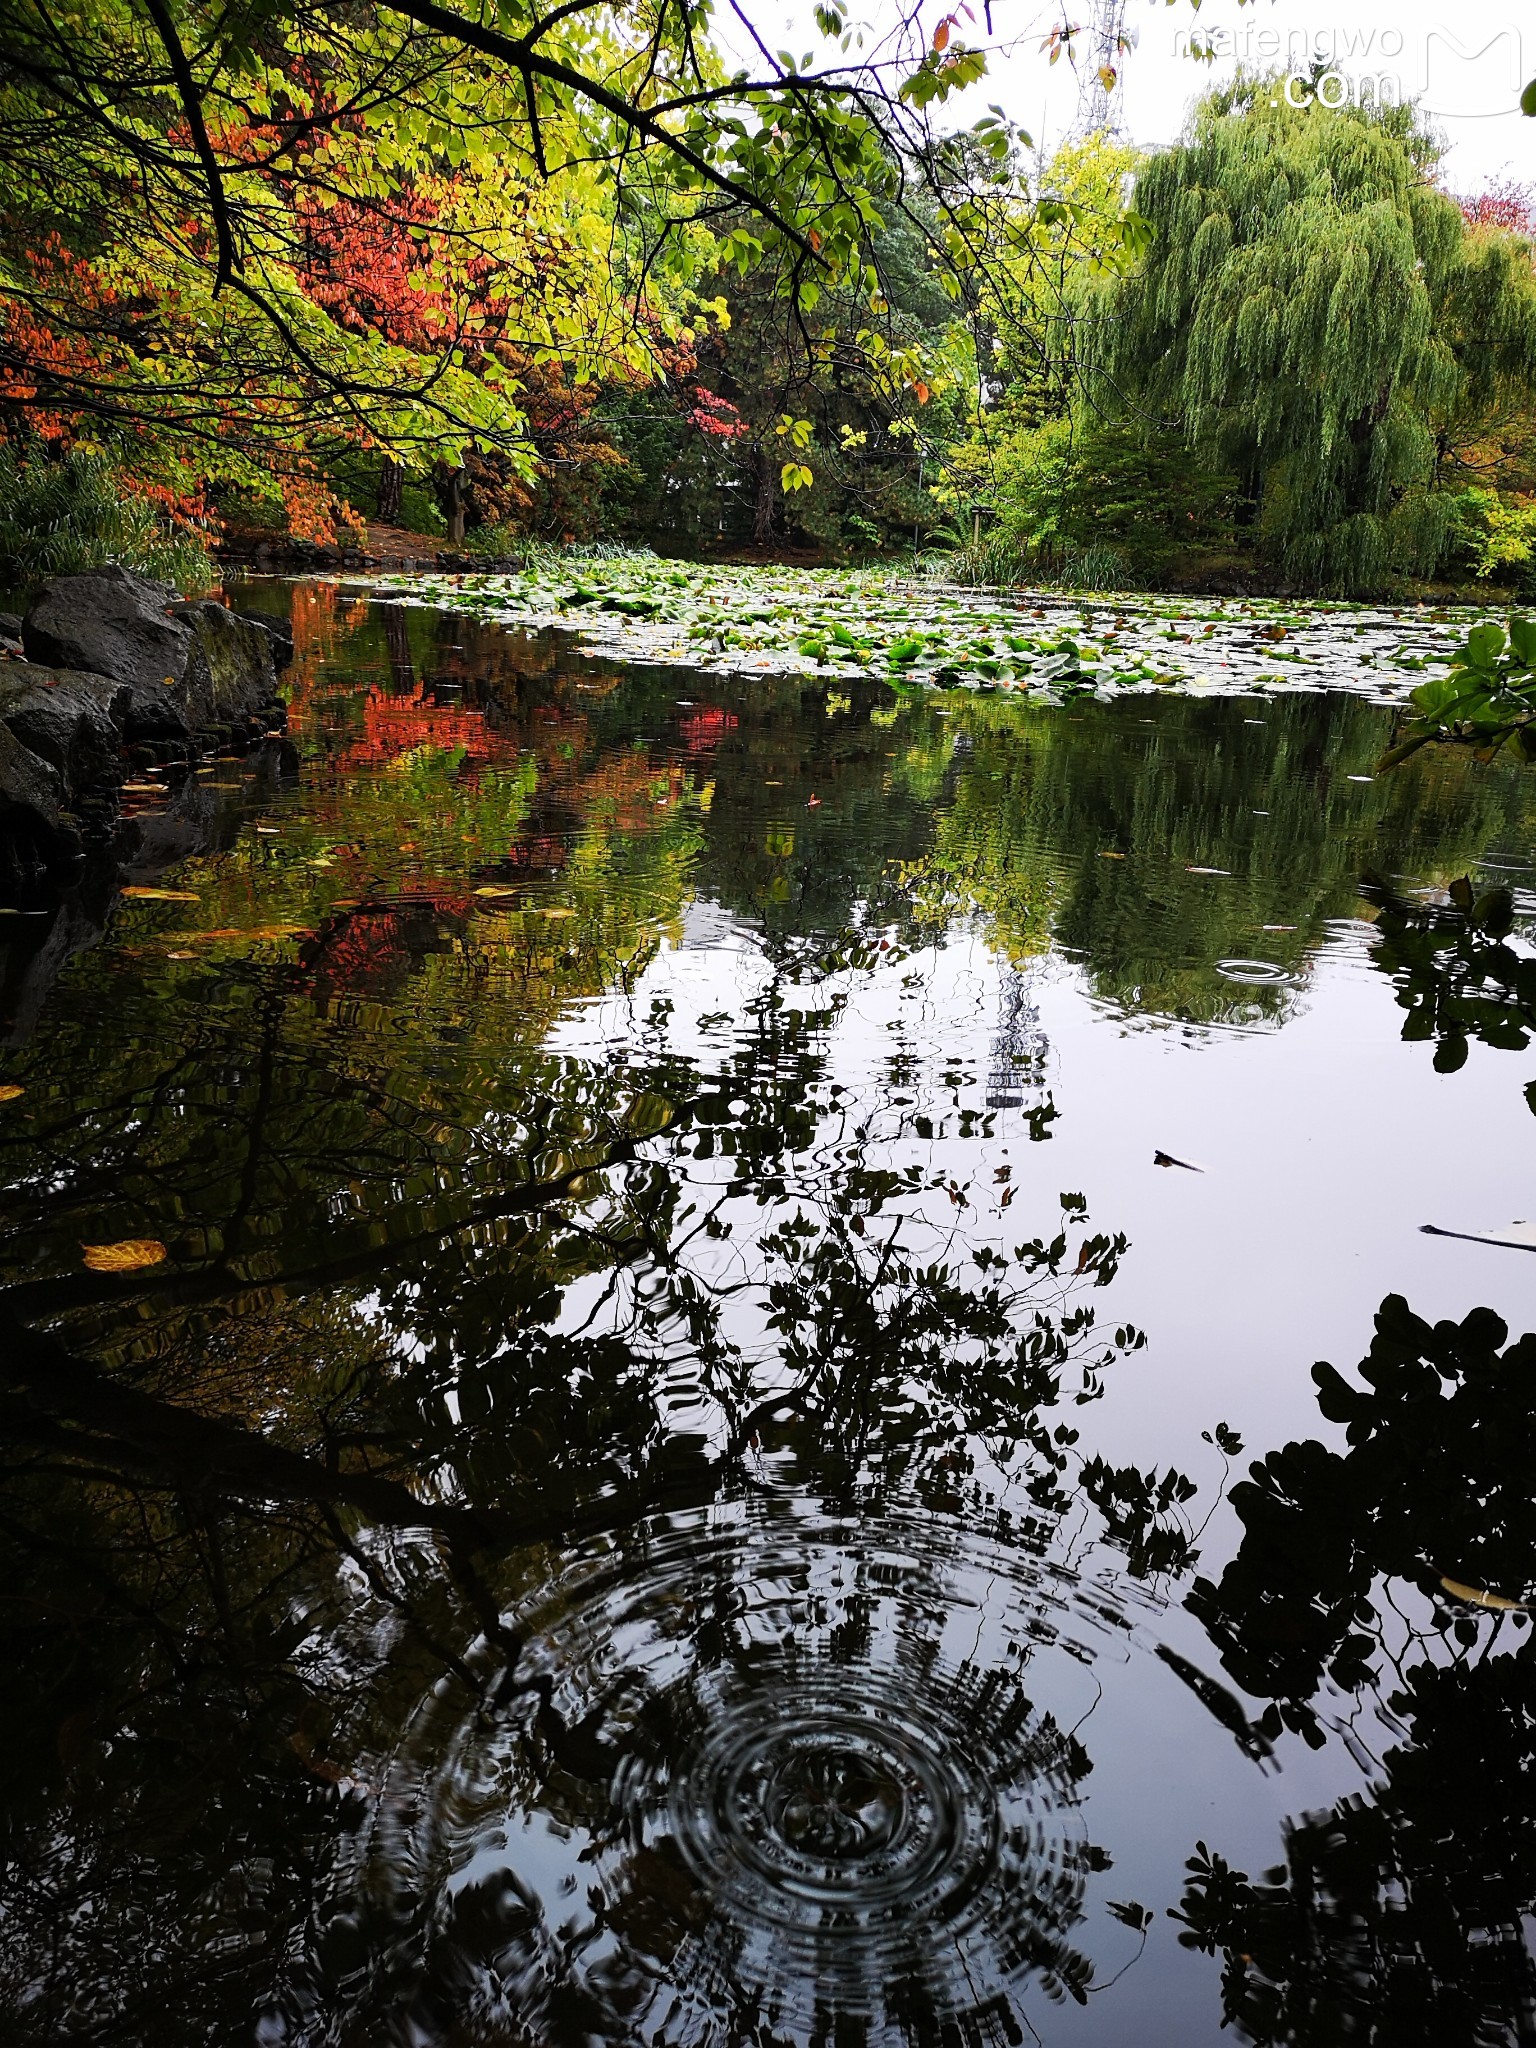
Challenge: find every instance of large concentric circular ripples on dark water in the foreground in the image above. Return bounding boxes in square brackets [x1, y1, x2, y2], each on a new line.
[356, 1499, 1163, 2044]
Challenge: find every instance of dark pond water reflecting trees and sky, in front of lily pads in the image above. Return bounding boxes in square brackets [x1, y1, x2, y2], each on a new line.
[0, 584, 1536, 2048]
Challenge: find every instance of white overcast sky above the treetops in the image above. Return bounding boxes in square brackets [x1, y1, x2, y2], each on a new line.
[717, 0, 1536, 193]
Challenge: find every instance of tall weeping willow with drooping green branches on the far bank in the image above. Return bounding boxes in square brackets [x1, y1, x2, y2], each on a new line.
[1100, 78, 1536, 592]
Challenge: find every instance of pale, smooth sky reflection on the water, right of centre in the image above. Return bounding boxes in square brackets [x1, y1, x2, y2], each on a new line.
[557, 876, 1536, 2048]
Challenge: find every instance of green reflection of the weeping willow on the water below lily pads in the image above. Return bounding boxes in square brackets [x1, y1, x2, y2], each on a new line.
[901, 694, 1524, 1022]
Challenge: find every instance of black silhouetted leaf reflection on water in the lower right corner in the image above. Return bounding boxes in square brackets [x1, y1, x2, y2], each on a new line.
[1182, 1296, 1536, 2048]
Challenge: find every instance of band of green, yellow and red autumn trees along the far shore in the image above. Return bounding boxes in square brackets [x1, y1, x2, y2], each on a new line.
[0, 37, 1536, 606]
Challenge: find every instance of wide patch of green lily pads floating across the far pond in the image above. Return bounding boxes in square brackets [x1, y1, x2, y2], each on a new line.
[354, 551, 1479, 705]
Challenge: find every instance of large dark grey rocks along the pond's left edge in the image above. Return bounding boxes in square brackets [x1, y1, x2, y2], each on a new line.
[0, 567, 293, 891]
